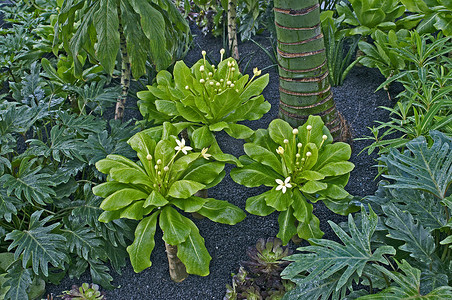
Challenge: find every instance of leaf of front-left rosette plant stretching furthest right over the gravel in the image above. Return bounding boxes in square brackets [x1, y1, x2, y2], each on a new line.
[197, 198, 246, 225]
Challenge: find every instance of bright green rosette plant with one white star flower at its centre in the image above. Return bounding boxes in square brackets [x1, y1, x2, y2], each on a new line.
[231, 116, 354, 245]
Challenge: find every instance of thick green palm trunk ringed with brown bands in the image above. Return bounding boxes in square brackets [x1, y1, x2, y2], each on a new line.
[274, 0, 341, 138]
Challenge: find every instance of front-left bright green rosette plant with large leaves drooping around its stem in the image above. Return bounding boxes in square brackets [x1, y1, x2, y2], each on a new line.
[93, 123, 245, 281]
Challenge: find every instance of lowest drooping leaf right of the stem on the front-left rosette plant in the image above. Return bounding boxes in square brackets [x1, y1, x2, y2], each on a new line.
[177, 219, 212, 276]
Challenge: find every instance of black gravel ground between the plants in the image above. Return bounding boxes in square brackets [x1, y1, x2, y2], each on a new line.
[47, 28, 395, 300]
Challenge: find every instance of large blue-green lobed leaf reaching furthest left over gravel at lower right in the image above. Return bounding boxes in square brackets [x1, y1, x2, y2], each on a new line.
[281, 207, 395, 290]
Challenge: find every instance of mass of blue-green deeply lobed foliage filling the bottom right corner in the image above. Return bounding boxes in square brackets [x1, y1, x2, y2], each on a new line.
[282, 131, 452, 299]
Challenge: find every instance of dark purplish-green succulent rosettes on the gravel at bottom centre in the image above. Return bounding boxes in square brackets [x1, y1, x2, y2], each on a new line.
[224, 238, 293, 300]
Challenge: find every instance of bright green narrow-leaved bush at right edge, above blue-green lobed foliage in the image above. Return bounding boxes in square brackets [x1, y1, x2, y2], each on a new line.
[363, 31, 452, 153]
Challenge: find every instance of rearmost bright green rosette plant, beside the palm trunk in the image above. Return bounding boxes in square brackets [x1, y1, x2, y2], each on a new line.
[137, 50, 271, 151]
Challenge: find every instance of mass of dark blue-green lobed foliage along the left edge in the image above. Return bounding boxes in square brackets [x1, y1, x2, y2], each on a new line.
[0, 59, 135, 299]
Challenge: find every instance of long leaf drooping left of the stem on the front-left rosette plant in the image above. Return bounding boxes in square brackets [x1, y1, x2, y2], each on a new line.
[127, 211, 160, 273]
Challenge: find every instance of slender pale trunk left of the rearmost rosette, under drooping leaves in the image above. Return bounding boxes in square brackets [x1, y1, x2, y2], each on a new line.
[115, 4, 131, 121]
